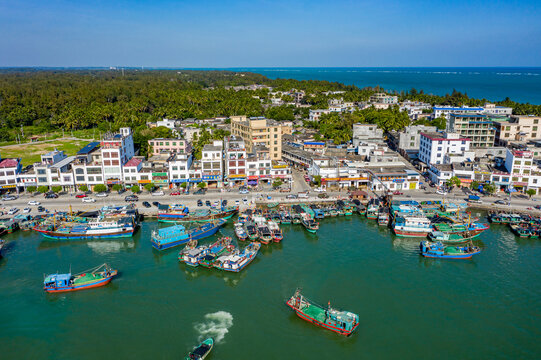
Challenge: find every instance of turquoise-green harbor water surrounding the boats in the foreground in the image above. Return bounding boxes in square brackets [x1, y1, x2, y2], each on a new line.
[0, 215, 541, 360]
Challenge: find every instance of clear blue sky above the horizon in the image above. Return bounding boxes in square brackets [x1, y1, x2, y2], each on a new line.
[0, 0, 541, 68]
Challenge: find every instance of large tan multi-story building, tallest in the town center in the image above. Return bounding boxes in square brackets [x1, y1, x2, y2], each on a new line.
[231, 116, 292, 160]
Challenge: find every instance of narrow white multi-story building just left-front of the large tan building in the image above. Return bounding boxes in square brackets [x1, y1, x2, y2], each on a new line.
[224, 136, 247, 186]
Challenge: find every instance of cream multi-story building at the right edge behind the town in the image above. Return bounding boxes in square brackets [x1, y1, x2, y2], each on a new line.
[494, 115, 541, 146]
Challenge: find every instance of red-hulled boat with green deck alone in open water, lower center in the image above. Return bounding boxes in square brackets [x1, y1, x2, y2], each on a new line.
[286, 289, 359, 336]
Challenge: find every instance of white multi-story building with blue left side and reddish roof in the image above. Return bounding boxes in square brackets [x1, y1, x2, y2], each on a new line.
[419, 132, 471, 165]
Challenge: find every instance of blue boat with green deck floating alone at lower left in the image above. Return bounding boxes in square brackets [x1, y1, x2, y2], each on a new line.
[43, 264, 118, 293]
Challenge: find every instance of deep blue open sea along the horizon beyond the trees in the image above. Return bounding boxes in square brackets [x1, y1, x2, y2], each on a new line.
[226, 67, 541, 104]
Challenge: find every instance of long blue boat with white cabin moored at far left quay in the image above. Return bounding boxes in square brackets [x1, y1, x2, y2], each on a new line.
[34, 217, 136, 240]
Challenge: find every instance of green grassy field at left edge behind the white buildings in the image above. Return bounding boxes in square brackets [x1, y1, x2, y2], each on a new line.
[0, 139, 89, 165]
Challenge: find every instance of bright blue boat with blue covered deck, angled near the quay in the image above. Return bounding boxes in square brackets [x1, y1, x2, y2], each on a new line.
[150, 219, 226, 250]
